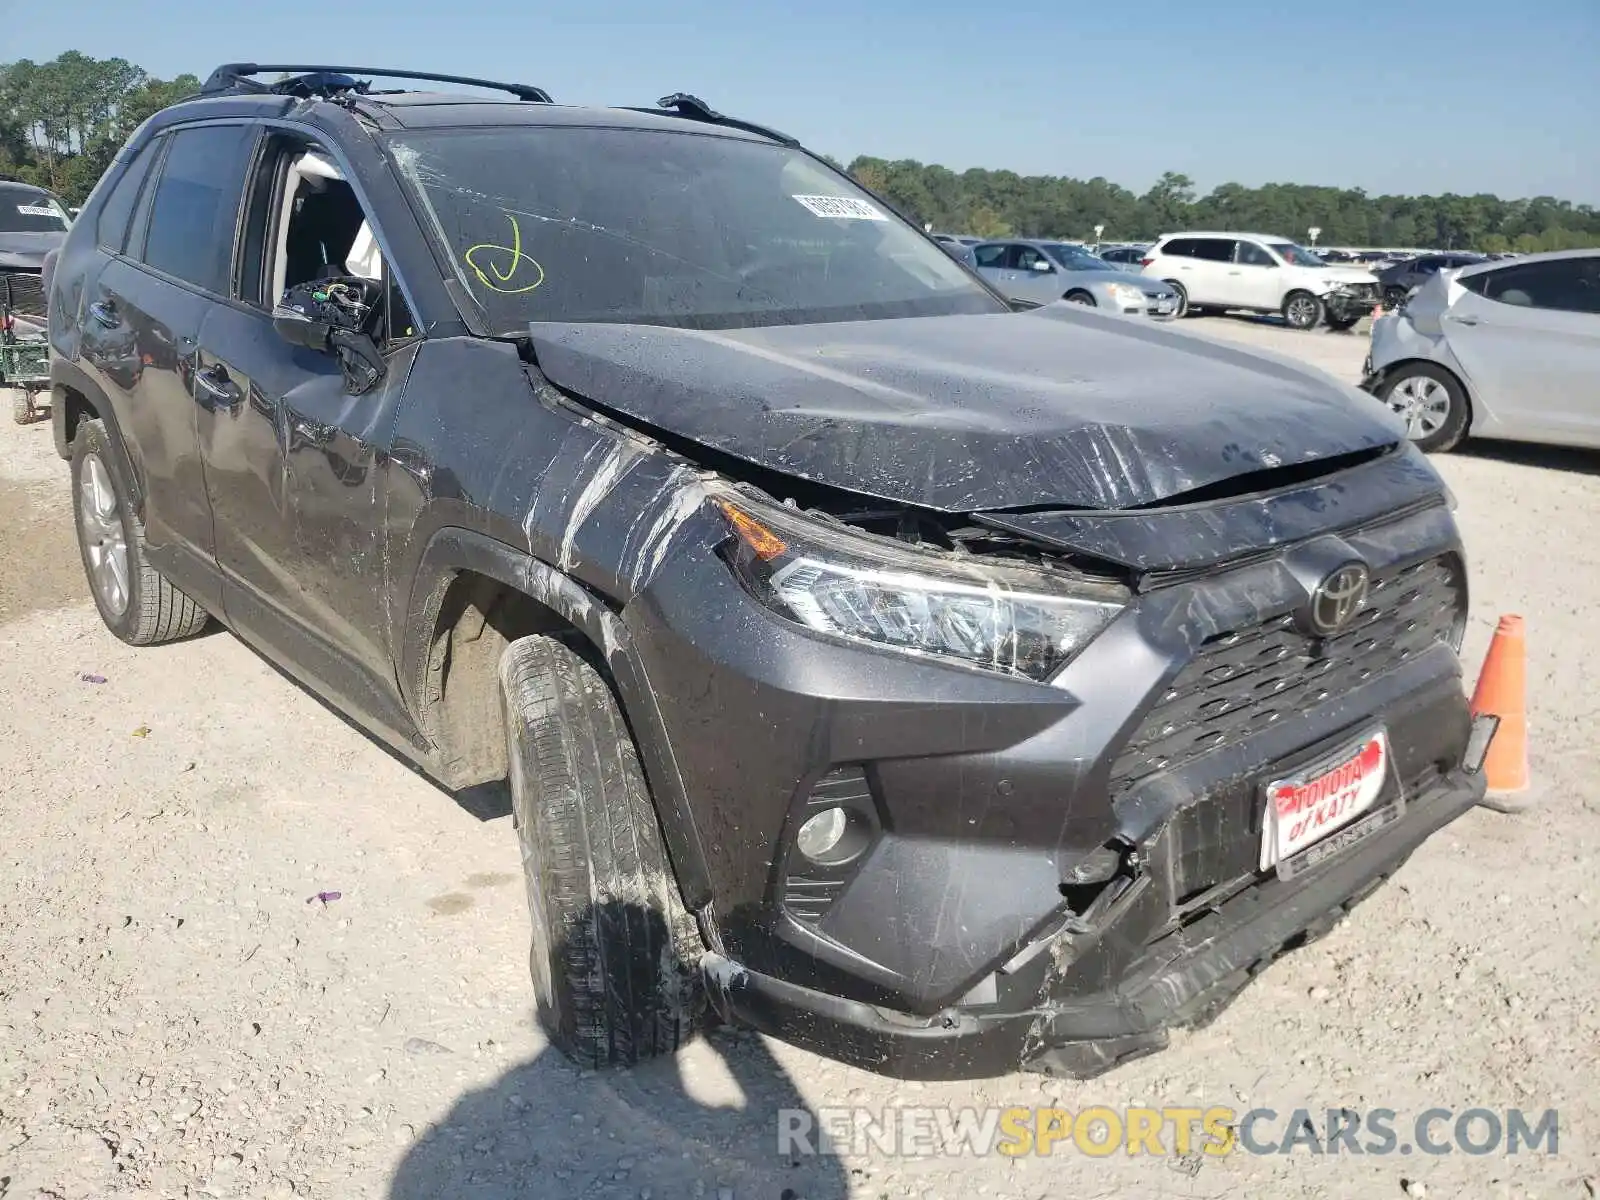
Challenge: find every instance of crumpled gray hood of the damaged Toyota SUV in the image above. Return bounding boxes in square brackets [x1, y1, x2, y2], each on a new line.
[530, 306, 1400, 512]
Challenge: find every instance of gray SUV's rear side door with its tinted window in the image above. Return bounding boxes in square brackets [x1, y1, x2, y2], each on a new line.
[82, 123, 256, 611]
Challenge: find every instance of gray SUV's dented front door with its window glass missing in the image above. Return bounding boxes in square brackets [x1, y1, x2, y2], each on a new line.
[195, 129, 414, 731]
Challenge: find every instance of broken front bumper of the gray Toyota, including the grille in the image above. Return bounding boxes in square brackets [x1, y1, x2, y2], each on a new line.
[622, 489, 1474, 1074]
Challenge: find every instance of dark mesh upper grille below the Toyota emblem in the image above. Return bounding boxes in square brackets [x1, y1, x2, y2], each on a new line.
[1110, 557, 1462, 798]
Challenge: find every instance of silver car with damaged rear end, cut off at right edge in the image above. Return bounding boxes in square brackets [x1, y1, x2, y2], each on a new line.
[1362, 250, 1600, 451]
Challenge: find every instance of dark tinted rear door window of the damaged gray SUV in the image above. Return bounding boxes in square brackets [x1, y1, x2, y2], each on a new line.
[142, 125, 256, 296]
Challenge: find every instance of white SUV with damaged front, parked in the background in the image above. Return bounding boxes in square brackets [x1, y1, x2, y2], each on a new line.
[1142, 234, 1379, 330]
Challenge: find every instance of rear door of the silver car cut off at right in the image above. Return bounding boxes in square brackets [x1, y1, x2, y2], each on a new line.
[1442, 254, 1600, 446]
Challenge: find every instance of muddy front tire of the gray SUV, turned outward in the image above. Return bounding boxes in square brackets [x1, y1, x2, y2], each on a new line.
[499, 637, 704, 1067]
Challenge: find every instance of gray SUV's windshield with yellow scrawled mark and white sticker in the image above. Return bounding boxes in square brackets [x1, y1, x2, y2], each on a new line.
[390, 126, 1006, 333]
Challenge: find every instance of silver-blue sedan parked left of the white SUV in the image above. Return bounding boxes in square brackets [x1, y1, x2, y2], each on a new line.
[973, 238, 1178, 320]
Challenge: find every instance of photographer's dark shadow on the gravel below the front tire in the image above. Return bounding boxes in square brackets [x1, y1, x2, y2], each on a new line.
[389, 912, 850, 1200]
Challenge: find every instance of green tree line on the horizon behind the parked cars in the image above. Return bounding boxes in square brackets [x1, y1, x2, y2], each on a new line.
[0, 50, 1600, 253]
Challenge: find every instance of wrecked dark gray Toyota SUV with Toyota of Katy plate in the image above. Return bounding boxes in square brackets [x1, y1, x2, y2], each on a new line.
[50, 64, 1483, 1077]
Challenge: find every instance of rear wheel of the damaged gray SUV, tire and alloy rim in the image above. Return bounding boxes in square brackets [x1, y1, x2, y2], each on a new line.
[72, 421, 210, 646]
